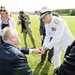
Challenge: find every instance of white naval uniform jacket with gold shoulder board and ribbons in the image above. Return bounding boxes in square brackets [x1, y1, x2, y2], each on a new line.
[43, 16, 74, 50]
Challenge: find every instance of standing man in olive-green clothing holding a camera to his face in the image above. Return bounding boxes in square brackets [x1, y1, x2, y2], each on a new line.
[18, 10, 36, 48]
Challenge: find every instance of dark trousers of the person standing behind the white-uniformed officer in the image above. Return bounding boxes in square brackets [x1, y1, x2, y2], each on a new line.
[41, 38, 54, 62]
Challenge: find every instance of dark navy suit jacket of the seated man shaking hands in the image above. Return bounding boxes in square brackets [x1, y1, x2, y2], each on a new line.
[0, 43, 34, 75]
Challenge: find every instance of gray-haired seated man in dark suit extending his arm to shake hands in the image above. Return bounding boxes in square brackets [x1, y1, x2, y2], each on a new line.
[0, 27, 40, 75]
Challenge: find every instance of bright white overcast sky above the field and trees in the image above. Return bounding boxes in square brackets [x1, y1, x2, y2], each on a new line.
[0, 0, 75, 11]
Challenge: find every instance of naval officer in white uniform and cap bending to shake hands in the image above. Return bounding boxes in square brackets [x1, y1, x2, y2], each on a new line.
[40, 8, 74, 69]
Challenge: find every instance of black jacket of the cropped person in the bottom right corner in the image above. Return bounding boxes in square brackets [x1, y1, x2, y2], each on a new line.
[58, 41, 75, 75]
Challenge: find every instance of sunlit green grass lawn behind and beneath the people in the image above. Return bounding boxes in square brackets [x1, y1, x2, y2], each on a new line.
[13, 15, 75, 75]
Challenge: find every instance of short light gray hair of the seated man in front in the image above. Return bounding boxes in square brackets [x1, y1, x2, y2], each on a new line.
[2, 27, 16, 41]
